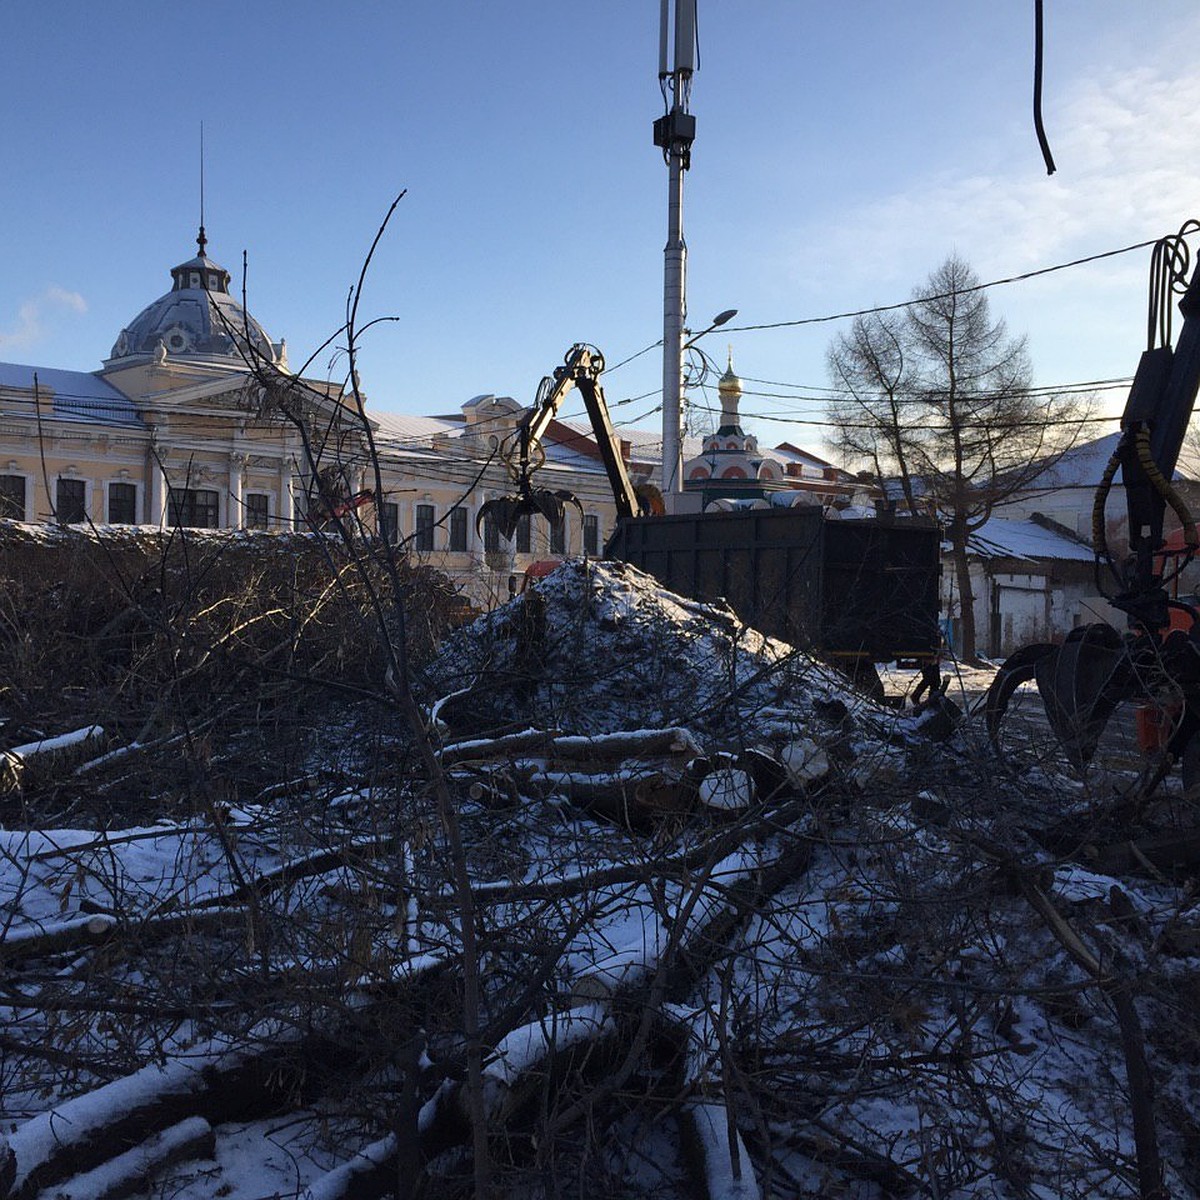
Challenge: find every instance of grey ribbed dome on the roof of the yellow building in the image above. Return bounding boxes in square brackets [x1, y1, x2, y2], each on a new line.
[106, 227, 282, 367]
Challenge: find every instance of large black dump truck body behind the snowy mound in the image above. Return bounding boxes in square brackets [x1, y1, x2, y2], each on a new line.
[607, 508, 941, 662]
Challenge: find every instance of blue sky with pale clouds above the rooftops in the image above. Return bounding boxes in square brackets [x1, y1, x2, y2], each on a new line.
[0, 0, 1200, 458]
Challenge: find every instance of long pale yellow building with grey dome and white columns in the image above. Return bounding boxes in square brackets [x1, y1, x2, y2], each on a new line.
[0, 228, 658, 602]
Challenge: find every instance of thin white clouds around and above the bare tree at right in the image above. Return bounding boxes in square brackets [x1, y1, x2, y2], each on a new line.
[758, 41, 1200, 398]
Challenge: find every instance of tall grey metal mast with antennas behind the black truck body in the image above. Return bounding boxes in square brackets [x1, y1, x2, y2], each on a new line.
[654, 0, 696, 499]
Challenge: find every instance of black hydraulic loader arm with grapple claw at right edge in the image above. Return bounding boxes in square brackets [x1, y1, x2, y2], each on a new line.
[985, 222, 1200, 788]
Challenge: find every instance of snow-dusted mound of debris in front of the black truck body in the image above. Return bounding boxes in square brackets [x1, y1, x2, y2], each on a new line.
[433, 560, 870, 744]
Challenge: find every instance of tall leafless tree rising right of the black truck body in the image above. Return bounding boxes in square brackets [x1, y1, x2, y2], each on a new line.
[828, 254, 1087, 660]
